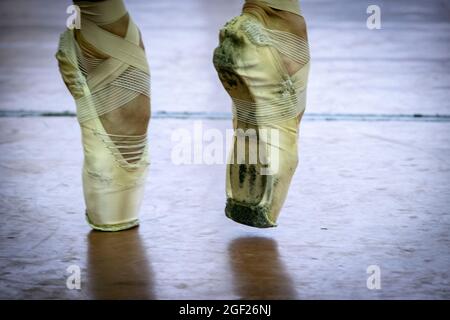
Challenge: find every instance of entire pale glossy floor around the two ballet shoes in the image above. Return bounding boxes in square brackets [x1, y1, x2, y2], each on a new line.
[0, 0, 450, 299]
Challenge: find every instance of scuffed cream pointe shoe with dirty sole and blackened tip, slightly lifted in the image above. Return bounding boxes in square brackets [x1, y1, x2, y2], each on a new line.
[214, 1, 309, 228]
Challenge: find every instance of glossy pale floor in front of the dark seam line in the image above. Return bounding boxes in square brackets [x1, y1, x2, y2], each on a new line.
[0, 118, 450, 299]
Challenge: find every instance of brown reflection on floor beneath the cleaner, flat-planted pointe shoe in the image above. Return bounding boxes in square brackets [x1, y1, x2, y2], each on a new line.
[86, 228, 156, 299]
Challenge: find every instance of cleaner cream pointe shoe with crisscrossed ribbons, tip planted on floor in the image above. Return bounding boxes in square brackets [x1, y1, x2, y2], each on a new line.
[56, 0, 150, 231]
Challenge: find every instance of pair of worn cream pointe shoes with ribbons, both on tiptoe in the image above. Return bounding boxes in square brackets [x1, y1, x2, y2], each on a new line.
[56, 0, 309, 231]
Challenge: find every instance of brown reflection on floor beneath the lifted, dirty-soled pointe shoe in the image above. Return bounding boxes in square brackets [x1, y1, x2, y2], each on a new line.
[228, 237, 298, 299]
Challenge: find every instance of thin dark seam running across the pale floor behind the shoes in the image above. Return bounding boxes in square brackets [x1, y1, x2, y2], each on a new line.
[0, 110, 450, 122]
